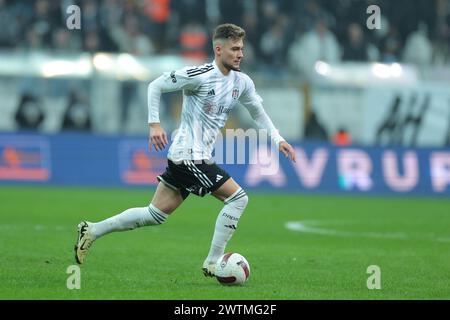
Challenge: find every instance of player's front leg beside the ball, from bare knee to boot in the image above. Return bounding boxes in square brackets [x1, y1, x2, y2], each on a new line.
[203, 178, 248, 276]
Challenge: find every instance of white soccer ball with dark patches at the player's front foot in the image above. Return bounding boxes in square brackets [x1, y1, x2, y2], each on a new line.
[214, 252, 250, 285]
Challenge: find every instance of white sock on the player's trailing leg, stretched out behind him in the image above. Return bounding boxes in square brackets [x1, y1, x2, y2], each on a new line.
[91, 204, 169, 238]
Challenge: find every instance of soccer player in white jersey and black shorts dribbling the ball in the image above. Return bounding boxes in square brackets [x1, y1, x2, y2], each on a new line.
[75, 24, 295, 276]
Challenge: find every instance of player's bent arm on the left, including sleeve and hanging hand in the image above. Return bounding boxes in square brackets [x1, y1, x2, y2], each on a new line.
[148, 68, 201, 151]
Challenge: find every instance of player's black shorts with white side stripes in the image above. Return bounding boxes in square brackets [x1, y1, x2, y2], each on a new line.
[157, 160, 230, 199]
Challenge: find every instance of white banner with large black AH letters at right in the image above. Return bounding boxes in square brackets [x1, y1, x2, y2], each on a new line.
[360, 83, 450, 147]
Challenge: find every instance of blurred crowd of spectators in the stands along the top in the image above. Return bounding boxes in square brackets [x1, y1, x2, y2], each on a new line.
[0, 0, 450, 72]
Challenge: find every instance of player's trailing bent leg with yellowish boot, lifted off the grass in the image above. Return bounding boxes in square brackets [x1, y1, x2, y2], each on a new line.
[75, 183, 185, 264]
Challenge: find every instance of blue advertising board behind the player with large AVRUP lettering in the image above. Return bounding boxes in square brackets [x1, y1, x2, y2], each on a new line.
[0, 133, 450, 197]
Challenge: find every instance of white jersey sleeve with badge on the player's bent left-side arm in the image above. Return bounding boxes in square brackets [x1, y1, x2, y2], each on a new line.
[147, 67, 202, 123]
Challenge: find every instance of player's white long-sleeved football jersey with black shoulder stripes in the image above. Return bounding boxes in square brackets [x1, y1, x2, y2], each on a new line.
[148, 61, 284, 161]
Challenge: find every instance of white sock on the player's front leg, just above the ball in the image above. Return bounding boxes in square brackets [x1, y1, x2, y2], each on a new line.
[205, 189, 248, 264]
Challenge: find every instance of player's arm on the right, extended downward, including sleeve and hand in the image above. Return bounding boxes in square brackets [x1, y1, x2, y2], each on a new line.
[240, 78, 296, 162]
